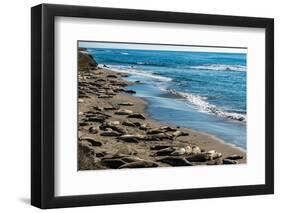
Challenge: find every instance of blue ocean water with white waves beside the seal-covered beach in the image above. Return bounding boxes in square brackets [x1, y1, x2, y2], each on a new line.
[88, 48, 247, 149]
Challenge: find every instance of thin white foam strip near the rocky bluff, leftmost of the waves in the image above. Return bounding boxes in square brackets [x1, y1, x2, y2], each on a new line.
[103, 65, 172, 81]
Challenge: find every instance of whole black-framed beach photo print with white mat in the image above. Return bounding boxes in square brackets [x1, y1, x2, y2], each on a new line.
[31, 4, 274, 208]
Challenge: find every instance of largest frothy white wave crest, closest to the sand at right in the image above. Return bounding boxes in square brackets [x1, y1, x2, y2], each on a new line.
[168, 90, 247, 122]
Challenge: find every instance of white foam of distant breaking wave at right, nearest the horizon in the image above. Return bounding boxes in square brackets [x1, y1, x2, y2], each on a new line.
[190, 64, 247, 72]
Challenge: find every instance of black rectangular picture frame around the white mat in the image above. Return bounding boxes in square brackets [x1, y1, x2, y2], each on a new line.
[31, 4, 274, 209]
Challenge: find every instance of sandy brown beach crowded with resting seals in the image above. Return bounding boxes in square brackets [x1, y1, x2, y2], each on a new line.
[78, 48, 246, 170]
